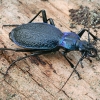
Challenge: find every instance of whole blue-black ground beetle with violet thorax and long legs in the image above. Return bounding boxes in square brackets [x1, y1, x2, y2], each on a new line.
[0, 10, 98, 89]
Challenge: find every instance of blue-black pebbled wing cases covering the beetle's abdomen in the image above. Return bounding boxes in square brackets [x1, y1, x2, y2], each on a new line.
[9, 23, 63, 49]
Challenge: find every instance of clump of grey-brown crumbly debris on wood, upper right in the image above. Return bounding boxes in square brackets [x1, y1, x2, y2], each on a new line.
[69, 6, 100, 29]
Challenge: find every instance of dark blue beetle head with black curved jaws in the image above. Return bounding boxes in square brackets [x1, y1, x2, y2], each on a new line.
[78, 41, 97, 57]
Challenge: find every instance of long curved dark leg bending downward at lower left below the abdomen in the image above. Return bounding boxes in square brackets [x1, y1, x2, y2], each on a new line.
[4, 50, 52, 78]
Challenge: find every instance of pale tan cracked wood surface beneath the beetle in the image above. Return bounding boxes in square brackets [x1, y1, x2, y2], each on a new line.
[0, 0, 100, 100]
